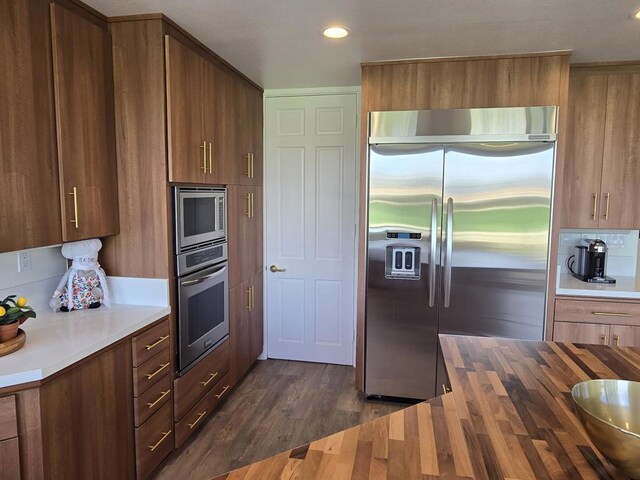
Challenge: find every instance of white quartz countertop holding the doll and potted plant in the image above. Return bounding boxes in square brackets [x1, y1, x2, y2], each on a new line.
[0, 305, 171, 388]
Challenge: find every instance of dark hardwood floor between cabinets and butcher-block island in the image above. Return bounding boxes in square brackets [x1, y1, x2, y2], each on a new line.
[155, 360, 407, 480]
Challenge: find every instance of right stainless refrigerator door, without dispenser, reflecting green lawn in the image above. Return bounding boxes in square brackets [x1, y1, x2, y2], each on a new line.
[439, 143, 555, 340]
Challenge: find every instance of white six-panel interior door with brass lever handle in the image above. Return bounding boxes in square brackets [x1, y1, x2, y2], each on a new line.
[265, 93, 357, 365]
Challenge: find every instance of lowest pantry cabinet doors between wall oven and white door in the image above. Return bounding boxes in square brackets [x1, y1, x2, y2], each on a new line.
[229, 272, 264, 384]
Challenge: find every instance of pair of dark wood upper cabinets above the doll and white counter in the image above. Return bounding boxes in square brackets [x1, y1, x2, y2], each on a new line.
[0, 0, 118, 252]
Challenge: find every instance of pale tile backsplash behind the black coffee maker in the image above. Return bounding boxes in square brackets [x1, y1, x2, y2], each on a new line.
[558, 229, 640, 277]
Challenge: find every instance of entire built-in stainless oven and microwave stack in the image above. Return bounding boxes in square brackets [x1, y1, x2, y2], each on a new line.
[173, 186, 229, 375]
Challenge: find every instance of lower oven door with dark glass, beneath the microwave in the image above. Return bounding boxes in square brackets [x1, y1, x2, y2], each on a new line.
[178, 262, 229, 373]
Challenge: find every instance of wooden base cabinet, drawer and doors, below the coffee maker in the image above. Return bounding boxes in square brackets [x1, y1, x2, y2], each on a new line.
[553, 298, 640, 347]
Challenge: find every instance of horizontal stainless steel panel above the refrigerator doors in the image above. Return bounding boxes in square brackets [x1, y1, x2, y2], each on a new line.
[369, 106, 557, 144]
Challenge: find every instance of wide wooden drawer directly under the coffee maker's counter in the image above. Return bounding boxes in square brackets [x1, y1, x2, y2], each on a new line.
[554, 300, 640, 325]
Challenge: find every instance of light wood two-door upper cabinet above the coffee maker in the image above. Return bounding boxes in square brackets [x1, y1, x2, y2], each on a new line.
[557, 66, 640, 229]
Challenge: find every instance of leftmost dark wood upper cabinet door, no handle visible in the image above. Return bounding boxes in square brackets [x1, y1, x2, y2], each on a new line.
[0, 0, 62, 252]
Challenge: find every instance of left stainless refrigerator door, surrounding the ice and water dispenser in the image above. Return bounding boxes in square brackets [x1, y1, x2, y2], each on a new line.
[365, 145, 444, 399]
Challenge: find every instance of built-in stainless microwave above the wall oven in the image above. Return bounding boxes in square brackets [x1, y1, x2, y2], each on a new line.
[176, 189, 225, 252]
